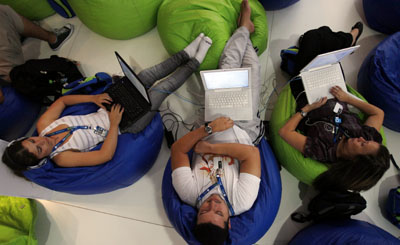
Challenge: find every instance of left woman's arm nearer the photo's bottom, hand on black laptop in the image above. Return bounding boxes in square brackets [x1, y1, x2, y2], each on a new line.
[53, 104, 124, 167]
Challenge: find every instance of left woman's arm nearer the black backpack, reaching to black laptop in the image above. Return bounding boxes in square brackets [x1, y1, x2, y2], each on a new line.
[36, 93, 112, 133]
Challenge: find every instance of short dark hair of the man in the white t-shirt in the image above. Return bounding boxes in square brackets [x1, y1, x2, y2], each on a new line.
[194, 219, 229, 245]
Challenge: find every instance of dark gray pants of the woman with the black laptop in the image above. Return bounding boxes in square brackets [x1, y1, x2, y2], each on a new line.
[121, 50, 200, 133]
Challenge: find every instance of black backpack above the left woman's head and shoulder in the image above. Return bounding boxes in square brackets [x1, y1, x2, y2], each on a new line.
[10, 55, 83, 104]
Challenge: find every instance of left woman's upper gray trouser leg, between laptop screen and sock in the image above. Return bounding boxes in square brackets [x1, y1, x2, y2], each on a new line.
[138, 50, 190, 87]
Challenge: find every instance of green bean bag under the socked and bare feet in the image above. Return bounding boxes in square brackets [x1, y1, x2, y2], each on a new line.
[157, 0, 268, 70]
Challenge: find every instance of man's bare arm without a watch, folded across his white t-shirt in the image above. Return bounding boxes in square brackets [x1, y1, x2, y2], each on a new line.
[194, 141, 261, 178]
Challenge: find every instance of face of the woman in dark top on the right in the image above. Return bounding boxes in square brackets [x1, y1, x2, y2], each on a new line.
[345, 137, 380, 157]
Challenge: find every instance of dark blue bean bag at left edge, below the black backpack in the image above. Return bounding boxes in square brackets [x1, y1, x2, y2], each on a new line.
[0, 86, 40, 141]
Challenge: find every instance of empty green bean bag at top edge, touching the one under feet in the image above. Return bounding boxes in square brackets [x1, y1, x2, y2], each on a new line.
[68, 0, 162, 40]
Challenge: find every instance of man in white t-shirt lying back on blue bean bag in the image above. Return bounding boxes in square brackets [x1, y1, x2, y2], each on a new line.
[171, 0, 261, 244]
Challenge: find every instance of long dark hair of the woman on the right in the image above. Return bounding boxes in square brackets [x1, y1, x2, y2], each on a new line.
[313, 145, 390, 191]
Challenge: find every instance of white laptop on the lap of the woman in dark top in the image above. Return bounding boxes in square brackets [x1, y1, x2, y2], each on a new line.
[300, 45, 360, 104]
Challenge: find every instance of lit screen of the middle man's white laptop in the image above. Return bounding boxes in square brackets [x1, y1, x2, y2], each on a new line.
[203, 69, 249, 89]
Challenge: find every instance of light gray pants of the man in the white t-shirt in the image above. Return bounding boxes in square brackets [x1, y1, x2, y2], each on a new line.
[219, 27, 261, 142]
